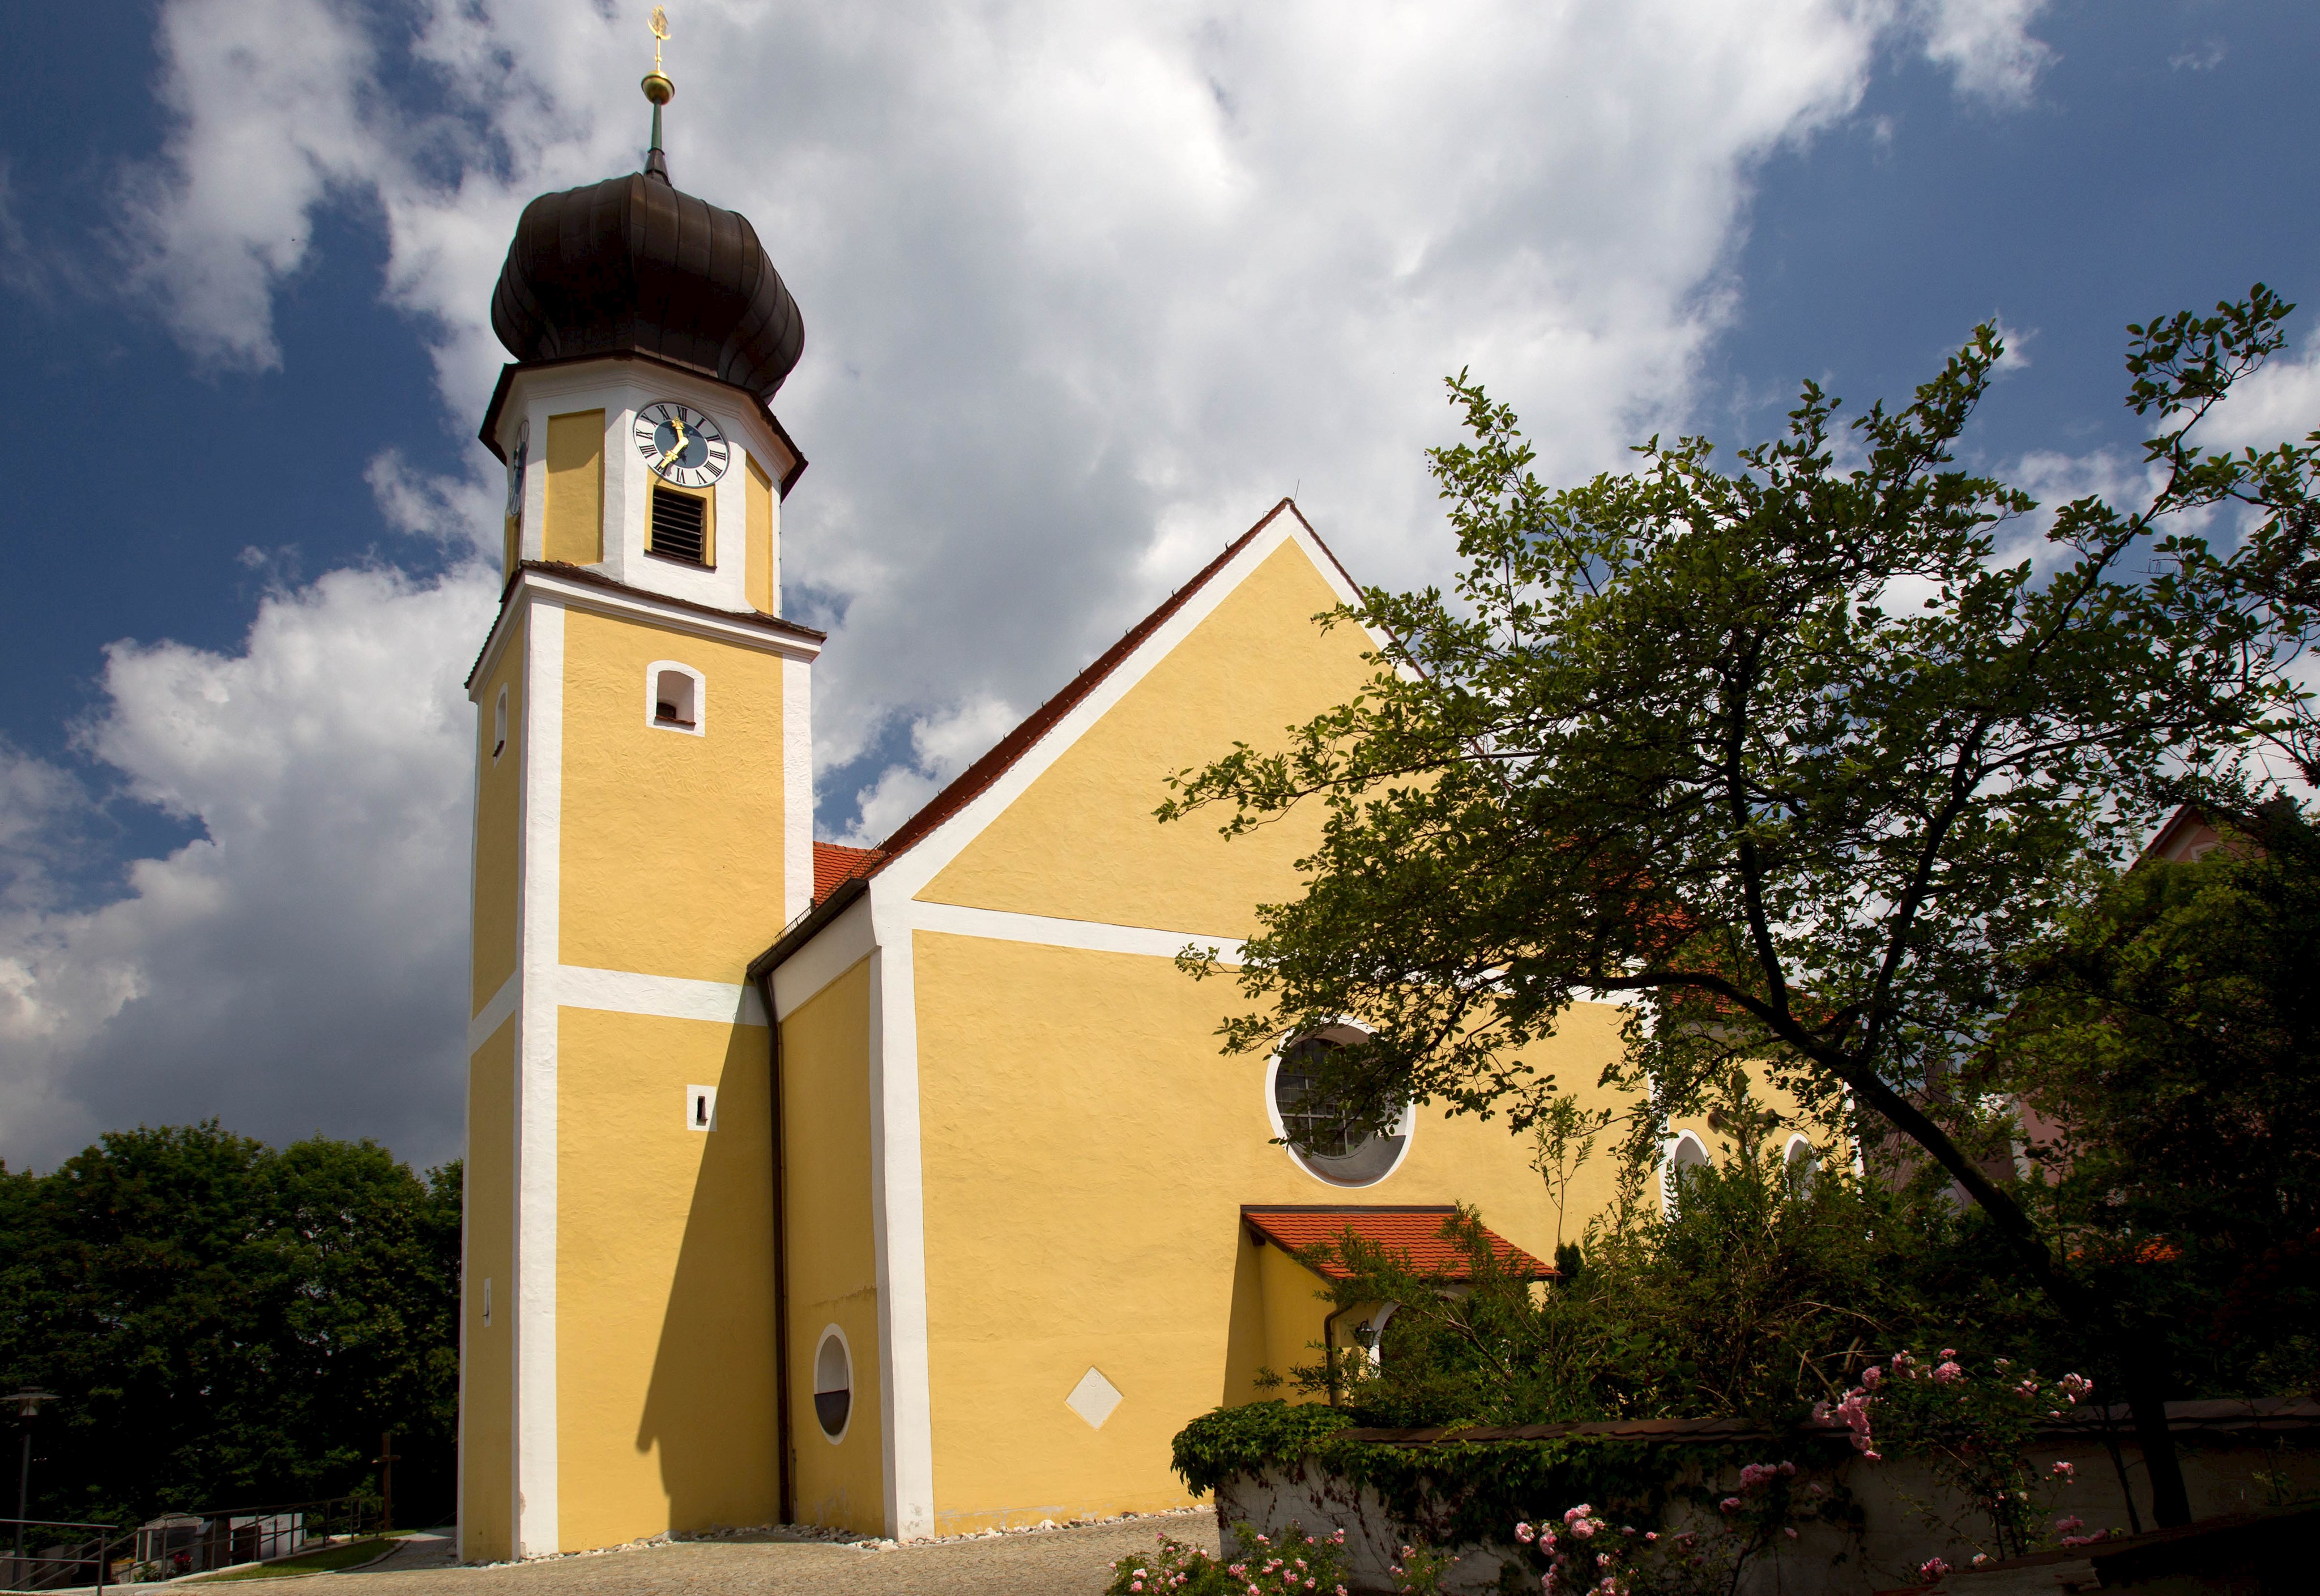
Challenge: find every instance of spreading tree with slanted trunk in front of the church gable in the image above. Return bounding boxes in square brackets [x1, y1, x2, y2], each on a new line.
[1160, 288, 2320, 1522]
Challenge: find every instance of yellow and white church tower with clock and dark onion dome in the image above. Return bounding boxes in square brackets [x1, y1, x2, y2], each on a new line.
[459, 31, 821, 1561]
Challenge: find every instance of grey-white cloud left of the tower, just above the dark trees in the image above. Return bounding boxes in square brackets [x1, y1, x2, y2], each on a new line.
[0, 566, 497, 1162]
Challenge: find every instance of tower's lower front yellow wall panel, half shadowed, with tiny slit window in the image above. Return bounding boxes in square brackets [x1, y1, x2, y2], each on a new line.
[557, 1009, 777, 1547]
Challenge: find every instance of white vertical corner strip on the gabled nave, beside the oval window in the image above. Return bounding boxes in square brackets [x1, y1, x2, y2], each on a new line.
[868, 881, 935, 1540]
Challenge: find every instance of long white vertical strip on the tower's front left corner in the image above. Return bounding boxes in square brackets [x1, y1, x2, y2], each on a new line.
[515, 603, 564, 1556]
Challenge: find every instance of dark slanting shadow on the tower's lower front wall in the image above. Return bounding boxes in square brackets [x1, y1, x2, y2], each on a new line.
[636, 1027, 779, 1529]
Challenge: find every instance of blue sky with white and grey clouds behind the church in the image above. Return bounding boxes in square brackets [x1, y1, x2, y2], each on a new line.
[0, 0, 2320, 1167]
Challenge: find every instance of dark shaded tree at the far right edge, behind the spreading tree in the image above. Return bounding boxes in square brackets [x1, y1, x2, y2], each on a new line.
[1974, 803, 2320, 1392]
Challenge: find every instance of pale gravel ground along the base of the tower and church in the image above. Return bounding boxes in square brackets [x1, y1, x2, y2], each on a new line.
[327, 1513, 1216, 1596]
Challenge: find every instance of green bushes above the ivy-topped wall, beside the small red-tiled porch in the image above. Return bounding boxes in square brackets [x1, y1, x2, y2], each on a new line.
[1290, 1081, 2039, 1427]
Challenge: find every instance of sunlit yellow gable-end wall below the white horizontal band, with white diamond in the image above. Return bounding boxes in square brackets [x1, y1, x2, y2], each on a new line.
[914, 933, 1619, 1533]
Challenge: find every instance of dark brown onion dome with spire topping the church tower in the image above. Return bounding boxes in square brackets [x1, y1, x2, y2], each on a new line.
[492, 67, 805, 399]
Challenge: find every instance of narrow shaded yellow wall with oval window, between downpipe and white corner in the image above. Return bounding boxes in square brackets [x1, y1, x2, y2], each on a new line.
[782, 958, 886, 1533]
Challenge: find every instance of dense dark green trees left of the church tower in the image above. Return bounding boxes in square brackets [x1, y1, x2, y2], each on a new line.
[0, 1123, 459, 1522]
